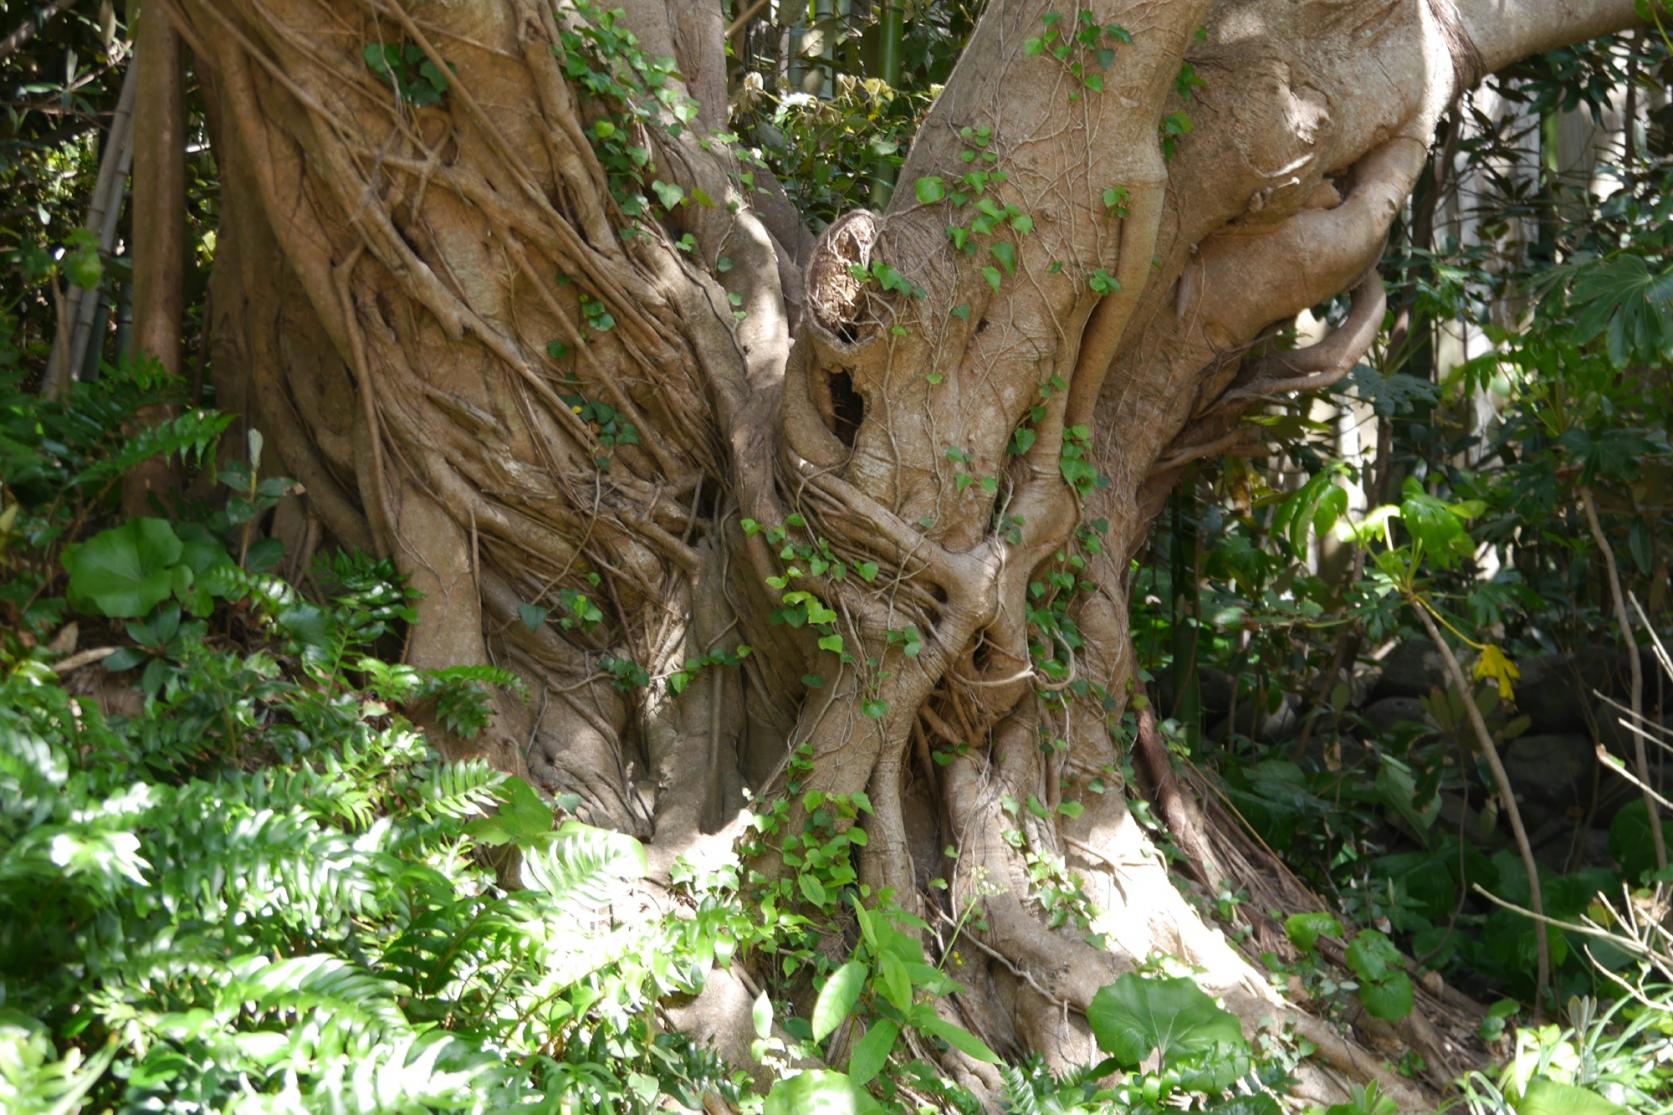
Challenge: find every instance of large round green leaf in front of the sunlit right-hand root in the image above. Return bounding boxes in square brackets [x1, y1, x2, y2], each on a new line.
[1086, 973, 1248, 1083]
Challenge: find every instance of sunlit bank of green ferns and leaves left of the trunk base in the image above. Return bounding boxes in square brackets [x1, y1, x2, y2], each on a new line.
[0, 377, 759, 1112]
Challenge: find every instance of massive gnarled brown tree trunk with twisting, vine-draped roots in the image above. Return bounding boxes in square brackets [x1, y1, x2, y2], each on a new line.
[157, 0, 1633, 1107]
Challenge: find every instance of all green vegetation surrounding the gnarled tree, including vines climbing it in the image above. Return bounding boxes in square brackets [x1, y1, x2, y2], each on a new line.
[0, 0, 1673, 1115]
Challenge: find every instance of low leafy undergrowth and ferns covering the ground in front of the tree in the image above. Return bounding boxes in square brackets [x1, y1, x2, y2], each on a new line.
[0, 368, 1666, 1115]
